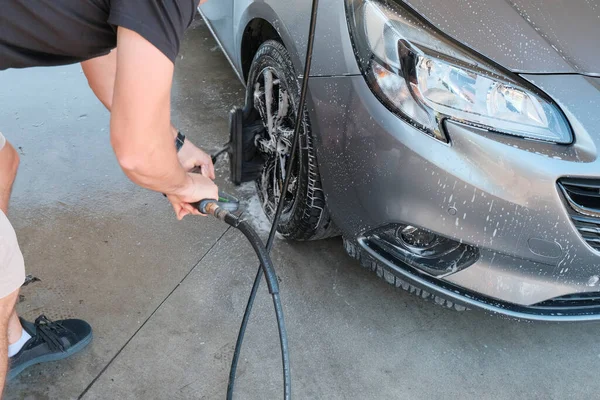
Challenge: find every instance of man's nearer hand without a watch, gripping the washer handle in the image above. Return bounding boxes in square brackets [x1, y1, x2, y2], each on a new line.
[167, 173, 219, 221]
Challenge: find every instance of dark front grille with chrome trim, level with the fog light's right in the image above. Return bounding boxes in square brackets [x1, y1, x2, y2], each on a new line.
[558, 179, 600, 251]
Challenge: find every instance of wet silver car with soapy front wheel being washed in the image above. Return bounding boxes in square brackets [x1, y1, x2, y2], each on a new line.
[199, 0, 600, 321]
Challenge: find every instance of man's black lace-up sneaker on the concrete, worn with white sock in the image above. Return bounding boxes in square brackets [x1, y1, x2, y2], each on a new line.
[8, 315, 92, 380]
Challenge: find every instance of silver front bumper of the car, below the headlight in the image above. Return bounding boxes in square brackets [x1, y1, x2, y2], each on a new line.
[310, 76, 600, 320]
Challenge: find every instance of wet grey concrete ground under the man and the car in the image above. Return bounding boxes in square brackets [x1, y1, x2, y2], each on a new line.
[0, 16, 600, 400]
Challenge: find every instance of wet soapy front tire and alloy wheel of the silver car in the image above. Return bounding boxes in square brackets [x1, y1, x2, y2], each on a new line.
[246, 40, 339, 240]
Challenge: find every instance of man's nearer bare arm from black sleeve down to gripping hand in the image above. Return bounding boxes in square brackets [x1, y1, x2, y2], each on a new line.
[110, 27, 218, 219]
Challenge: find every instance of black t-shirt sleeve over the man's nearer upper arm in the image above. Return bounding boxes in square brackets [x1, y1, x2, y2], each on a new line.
[108, 0, 198, 62]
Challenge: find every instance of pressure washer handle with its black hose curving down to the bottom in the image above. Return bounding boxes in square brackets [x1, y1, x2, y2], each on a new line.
[193, 192, 291, 400]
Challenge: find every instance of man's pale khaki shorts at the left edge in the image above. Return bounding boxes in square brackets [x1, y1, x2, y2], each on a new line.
[0, 133, 25, 299]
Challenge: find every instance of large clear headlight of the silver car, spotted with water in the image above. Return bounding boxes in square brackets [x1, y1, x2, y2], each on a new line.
[346, 0, 573, 144]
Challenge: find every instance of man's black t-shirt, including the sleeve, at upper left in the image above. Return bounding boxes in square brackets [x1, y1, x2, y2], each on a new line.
[0, 0, 199, 70]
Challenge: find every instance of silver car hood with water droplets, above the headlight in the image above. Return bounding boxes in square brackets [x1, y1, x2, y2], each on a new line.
[406, 0, 600, 76]
